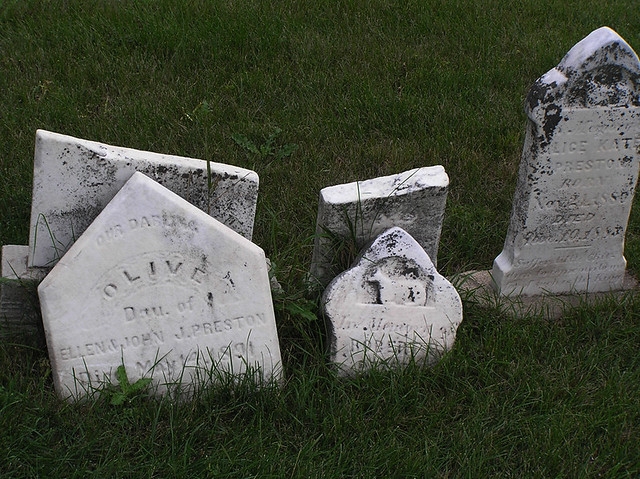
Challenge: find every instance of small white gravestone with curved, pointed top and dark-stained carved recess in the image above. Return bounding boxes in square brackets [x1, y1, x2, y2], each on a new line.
[322, 227, 462, 375]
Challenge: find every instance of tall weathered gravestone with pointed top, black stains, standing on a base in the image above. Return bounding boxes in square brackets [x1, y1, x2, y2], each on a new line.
[492, 27, 640, 295]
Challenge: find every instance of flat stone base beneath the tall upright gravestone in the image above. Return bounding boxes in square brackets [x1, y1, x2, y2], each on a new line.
[452, 271, 638, 319]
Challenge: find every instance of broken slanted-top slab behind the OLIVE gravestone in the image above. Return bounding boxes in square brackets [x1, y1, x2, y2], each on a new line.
[29, 130, 258, 267]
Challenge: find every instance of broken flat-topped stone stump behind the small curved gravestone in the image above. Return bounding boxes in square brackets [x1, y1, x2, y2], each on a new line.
[310, 166, 449, 287]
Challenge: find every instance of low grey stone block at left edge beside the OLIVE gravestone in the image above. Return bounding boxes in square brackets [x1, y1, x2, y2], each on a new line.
[0, 245, 48, 347]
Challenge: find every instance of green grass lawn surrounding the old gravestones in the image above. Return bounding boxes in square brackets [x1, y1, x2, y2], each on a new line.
[0, 0, 640, 478]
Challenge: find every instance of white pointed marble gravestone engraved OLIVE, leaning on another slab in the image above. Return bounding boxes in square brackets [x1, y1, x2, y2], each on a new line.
[38, 172, 281, 398]
